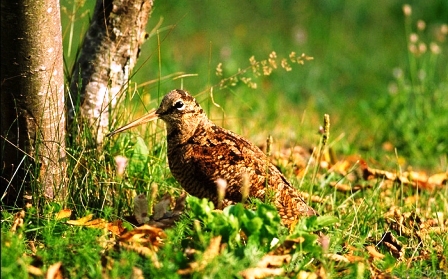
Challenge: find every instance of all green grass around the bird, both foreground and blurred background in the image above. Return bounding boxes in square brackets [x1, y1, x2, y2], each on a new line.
[1, 0, 448, 278]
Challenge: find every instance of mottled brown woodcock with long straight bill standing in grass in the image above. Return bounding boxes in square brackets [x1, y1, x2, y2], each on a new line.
[109, 89, 316, 225]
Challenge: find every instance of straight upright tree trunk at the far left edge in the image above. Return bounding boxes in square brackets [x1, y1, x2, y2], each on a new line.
[0, 0, 66, 205]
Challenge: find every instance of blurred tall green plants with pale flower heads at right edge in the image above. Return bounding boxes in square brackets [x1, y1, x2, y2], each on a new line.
[377, 10, 448, 167]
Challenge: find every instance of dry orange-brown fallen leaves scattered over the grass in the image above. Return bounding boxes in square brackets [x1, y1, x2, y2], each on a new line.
[10, 143, 448, 278]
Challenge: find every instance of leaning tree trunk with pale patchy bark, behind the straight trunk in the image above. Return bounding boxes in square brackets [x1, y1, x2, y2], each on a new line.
[68, 0, 153, 146]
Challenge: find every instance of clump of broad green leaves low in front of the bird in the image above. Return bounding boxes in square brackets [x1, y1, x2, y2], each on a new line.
[144, 197, 337, 278]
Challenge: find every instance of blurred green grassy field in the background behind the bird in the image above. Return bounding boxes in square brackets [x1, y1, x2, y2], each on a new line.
[63, 0, 448, 170]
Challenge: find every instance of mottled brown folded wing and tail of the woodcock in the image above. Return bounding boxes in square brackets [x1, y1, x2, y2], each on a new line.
[190, 126, 315, 220]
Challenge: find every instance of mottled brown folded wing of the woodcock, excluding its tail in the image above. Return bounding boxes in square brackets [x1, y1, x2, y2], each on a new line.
[189, 126, 276, 200]
